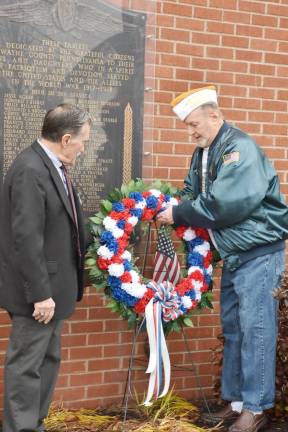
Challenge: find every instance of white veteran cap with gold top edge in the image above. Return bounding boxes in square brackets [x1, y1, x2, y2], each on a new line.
[171, 85, 218, 121]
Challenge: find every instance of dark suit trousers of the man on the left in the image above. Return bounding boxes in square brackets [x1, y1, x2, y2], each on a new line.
[3, 315, 63, 432]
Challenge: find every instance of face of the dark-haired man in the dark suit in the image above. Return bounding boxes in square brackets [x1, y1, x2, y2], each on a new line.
[61, 123, 91, 165]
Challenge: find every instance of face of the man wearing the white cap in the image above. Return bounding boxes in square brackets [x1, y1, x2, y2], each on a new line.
[184, 107, 219, 148]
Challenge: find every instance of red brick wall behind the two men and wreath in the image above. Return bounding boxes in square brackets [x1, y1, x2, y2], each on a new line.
[0, 0, 288, 407]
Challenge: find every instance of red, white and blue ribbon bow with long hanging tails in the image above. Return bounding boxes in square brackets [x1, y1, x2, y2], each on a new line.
[144, 281, 183, 406]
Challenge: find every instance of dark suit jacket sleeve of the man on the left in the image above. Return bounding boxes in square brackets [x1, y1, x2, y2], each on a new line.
[11, 167, 52, 303]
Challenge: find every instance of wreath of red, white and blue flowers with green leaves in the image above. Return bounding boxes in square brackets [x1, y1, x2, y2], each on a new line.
[86, 180, 213, 331]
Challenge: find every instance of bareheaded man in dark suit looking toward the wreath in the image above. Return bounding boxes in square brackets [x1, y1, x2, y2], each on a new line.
[0, 104, 91, 432]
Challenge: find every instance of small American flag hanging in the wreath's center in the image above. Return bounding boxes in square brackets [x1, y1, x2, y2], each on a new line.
[153, 226, 181, 286]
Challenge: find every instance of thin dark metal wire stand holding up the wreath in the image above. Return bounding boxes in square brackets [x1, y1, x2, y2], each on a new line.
[121, 221, 211, 430]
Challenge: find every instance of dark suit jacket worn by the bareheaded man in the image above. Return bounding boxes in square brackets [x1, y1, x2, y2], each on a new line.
[0, 141, 85, 319]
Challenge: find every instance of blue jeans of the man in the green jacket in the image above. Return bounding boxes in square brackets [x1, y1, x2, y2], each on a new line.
[221, 251, 285, 412]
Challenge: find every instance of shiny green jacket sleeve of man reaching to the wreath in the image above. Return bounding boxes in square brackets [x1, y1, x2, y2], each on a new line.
[173, 137, 272, 229]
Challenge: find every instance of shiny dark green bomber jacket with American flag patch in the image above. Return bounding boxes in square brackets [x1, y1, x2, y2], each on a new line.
[173, 122, 288, 270]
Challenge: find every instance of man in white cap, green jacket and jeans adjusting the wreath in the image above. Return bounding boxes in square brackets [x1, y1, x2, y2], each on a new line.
[158, 85, 288, 432]
